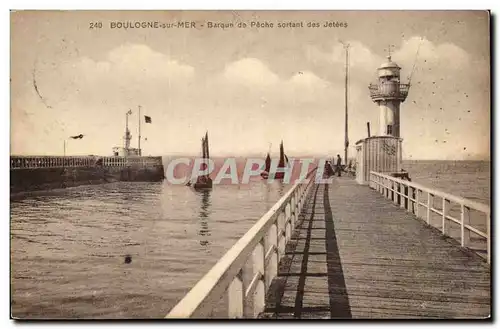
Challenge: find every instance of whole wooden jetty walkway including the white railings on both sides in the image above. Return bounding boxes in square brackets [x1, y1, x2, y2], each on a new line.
[167, 172, 491, 319]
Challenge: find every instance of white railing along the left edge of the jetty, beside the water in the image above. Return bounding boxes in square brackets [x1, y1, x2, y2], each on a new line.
[166, 169, 316, 318]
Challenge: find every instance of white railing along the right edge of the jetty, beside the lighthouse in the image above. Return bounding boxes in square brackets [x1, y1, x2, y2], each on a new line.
[370, 171, 491, 264]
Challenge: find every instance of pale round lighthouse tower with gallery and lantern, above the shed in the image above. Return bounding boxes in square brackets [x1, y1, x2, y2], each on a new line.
[369, 55, 409, 137]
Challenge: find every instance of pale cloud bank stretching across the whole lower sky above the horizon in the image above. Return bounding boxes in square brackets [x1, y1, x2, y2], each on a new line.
[12, 36, 489, 158]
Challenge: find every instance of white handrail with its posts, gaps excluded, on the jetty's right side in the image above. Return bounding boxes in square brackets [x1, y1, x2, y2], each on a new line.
[370, 171, 491, 264]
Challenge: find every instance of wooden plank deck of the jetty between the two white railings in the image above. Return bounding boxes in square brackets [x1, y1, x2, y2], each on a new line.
[260, 177, 491, 319]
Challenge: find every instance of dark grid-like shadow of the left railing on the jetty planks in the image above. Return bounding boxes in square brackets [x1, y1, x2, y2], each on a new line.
[260, 184, 351, 319]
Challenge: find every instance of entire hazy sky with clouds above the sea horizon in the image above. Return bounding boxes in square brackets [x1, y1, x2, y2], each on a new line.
[10, 11, 490, 160]
